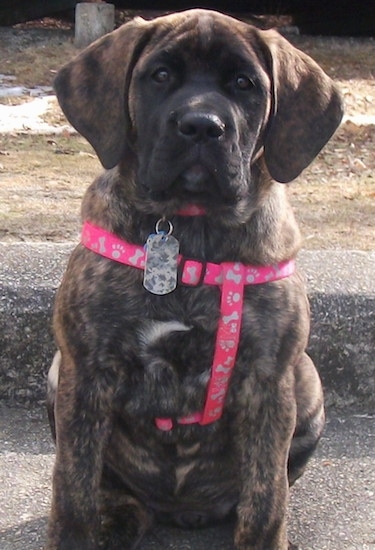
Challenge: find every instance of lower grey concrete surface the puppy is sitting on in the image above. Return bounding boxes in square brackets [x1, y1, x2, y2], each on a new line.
[0, 407, 375, 550]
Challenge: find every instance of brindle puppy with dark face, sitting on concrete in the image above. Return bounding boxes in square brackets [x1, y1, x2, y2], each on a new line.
[47, 10, 342, 550]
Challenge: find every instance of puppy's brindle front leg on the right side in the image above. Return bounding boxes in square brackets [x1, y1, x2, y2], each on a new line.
[235, 369, 296, 550]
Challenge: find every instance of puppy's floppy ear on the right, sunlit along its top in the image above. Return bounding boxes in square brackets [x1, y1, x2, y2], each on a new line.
[262, 31, 343, 183]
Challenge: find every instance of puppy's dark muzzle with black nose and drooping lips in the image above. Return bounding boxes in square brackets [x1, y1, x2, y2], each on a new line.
[139, 94, 238, 204]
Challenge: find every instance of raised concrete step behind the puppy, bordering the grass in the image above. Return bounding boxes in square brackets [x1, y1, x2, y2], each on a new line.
[0, 243, 375, 412]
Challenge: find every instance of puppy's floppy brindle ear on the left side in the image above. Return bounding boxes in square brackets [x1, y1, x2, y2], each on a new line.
[54, 17, 150, 168]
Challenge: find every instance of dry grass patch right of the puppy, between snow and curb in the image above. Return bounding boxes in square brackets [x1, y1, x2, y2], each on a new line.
[289, 122, 375, 250]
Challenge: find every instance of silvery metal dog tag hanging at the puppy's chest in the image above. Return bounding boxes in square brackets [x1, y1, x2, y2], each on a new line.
[143, 227, 180, 295]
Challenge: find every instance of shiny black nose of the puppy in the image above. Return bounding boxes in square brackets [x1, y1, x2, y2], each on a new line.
[177, 113, 225, 141]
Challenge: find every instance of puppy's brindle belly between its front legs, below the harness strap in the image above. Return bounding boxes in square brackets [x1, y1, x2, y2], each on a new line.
[106, 406, 238, 519]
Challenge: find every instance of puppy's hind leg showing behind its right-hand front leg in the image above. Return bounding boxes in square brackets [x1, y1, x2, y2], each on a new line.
[288, 354, 325, 485]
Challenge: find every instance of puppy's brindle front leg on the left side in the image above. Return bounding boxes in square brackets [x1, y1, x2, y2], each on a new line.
[46, 354, 115, 550]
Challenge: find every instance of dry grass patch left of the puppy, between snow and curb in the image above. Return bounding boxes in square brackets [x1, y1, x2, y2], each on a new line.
[0, 135, 100, 242]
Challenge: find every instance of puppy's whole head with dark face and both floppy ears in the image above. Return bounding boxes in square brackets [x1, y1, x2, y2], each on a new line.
[55, 10, 342, 216]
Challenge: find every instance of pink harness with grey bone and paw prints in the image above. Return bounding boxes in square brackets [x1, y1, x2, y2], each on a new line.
[81, 222, 295, 431]
